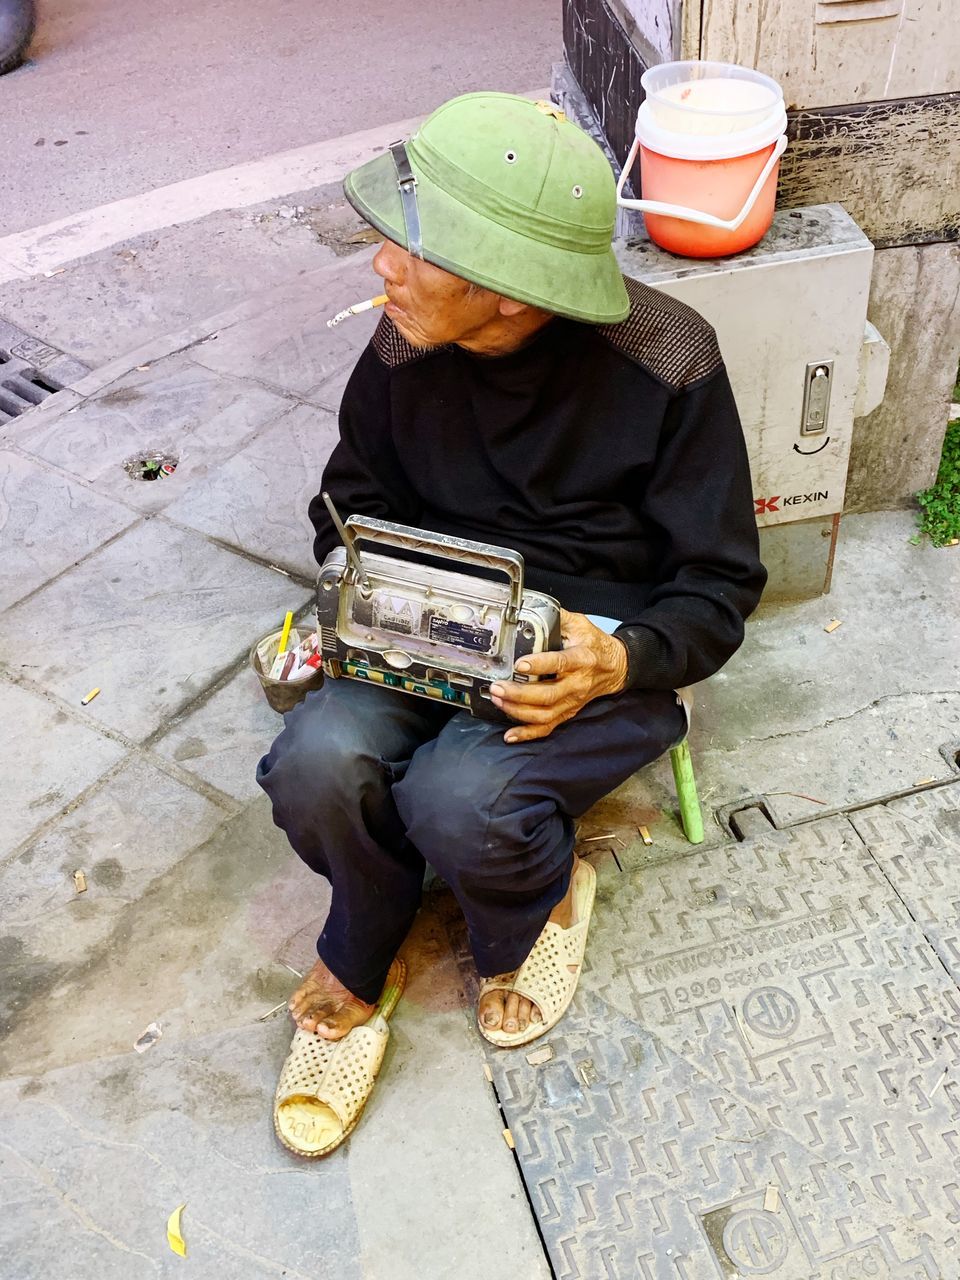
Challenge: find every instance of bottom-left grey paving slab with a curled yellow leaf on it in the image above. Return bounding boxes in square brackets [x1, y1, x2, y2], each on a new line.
[0, 1024, 363, 1280]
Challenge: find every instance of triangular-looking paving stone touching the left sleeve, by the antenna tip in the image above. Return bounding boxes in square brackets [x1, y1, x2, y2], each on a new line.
[166, 404, 349, 579]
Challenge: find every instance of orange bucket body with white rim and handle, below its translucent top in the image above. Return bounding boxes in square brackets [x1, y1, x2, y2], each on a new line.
[617, 76, 787, 257]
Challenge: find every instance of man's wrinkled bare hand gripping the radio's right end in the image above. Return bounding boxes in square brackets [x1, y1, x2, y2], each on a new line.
[490, 609, 627, 742]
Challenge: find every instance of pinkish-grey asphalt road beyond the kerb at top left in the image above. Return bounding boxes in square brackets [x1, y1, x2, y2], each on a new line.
[0, 0, 561, 234]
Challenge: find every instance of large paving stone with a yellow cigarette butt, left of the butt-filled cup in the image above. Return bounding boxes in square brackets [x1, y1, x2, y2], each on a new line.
[0, 517, 310, 740]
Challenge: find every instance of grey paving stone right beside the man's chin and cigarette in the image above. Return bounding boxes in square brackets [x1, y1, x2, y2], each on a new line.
[192, 253, 383, 394]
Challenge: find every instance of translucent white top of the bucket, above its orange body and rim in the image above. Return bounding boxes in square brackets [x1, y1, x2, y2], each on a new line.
[640, 61, 783, 136]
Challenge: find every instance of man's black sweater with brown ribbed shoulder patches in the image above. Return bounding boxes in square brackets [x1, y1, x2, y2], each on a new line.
[310, 272, 767, 689]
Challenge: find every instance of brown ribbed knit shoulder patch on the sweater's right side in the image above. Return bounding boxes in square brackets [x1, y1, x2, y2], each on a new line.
[599, 275, 723, 390]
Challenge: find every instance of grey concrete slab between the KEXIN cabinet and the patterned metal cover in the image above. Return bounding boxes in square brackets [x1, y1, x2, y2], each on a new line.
[695, 511, 960, 747]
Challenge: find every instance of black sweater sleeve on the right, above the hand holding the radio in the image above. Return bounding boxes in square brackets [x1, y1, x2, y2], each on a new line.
[616, 367, 767, 689]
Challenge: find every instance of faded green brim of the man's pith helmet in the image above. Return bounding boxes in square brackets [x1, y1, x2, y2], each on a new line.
[343, 151, 630, 324]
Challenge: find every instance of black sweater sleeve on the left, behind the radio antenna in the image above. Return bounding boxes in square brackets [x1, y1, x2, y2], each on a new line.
[308, 346, 419, 564]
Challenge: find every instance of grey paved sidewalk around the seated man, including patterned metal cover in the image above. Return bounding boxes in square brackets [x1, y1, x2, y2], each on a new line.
[0, 235, 960, 1280]
